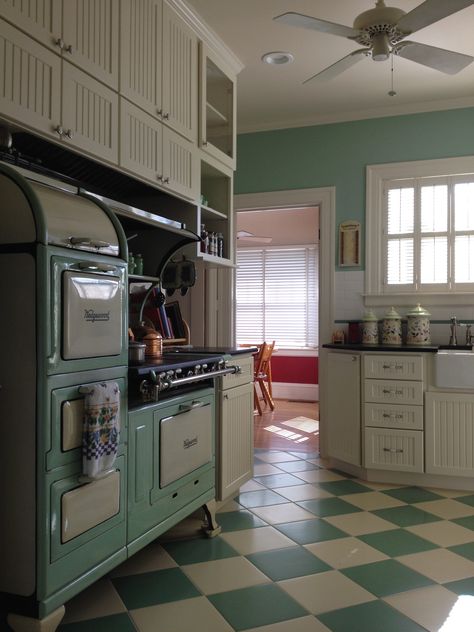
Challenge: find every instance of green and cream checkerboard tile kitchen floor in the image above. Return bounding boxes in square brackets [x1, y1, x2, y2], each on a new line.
[59, 450, 474, 632]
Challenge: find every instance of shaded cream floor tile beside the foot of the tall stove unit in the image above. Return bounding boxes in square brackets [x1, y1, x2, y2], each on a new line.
[62, 577, 127, 623]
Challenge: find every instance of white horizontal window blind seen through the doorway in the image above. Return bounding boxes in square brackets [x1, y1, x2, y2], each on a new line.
[236, 246, 318, 349]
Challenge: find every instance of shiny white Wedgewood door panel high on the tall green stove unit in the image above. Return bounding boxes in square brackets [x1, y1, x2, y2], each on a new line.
[62, 270, 122, 360]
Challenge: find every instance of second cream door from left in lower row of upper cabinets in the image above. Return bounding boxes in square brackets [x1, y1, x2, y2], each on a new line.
[62, 60, 118, 164]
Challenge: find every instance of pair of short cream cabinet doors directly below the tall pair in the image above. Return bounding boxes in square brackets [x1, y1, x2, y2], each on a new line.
[120, 98, 199, 199]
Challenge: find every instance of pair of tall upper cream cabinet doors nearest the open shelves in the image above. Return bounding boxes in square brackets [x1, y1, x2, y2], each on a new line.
[120, 0, 198, 142]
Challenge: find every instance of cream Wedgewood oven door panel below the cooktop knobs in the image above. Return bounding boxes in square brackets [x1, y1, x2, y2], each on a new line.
[160, 404, 212, 487]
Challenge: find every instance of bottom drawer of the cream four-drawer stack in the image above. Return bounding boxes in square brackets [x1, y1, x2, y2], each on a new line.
[364, 428, 423, 472]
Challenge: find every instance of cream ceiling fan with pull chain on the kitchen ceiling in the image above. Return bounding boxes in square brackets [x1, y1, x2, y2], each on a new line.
[273, 0, 474, 83]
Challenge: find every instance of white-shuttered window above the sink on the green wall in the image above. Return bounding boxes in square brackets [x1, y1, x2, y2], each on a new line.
[382, 175, 474, 292]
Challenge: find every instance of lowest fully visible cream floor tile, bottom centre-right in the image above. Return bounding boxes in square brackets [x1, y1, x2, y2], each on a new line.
[277, 571, 375, 614]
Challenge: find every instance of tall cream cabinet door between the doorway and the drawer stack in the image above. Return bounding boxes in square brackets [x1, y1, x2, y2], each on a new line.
[326, 351, 361, 465]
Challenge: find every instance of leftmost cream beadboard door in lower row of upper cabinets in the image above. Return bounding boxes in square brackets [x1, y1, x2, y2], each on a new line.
[0, 20, 61, 136]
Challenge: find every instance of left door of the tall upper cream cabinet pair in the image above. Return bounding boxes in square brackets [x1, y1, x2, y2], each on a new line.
[120, 0, 163, 117]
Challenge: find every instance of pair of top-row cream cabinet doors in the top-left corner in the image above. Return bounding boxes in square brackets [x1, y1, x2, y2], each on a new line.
[0, 0, 119, 89]
